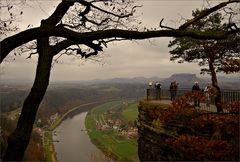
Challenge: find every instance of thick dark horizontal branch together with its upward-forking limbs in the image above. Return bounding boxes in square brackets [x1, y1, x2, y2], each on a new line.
[0, 0, 239, 63]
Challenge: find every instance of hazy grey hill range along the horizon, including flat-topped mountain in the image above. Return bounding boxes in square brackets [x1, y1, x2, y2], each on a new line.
[0, 73, 240, 89]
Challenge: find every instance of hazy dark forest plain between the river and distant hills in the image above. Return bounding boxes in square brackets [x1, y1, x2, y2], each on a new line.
[0, 83, 146, 113]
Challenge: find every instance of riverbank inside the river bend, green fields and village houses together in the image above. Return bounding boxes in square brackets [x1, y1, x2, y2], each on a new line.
[85, 101, 139, 161]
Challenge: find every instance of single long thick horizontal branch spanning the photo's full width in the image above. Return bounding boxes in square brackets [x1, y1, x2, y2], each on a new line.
[0, 26, 239, 62]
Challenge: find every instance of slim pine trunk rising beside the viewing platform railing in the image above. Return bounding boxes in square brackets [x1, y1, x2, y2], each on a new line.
[209, 55, 223, 112]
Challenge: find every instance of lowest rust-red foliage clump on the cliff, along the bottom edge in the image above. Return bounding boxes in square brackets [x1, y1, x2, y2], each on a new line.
[166, 135, 236, 161]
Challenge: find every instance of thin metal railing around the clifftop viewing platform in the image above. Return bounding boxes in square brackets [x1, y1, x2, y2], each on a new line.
[147, 88, 240, 112]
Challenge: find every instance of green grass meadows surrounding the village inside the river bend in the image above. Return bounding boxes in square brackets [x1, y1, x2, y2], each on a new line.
[85, 101, 139, 161]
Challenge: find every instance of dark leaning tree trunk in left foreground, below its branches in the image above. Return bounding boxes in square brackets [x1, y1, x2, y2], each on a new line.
[3, 38, 53, 161]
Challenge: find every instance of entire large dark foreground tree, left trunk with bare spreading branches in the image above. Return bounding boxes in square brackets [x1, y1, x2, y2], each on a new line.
[0, 0, 239, 161]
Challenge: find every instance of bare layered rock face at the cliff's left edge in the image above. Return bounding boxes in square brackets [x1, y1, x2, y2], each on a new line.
[138, 102, 175, 161]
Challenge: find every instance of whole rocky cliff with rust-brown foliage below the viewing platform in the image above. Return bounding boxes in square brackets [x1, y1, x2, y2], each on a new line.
[138, 100, 239, 161]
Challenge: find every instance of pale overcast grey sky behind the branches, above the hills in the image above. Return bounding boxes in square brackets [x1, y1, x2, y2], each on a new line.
[1, 0, 236, 81]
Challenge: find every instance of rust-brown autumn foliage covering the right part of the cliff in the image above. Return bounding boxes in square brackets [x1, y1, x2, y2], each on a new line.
[146, 93, 240, 161]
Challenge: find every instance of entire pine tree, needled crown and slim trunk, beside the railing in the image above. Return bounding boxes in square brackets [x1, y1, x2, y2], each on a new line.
[169, 10, 240, 112]
